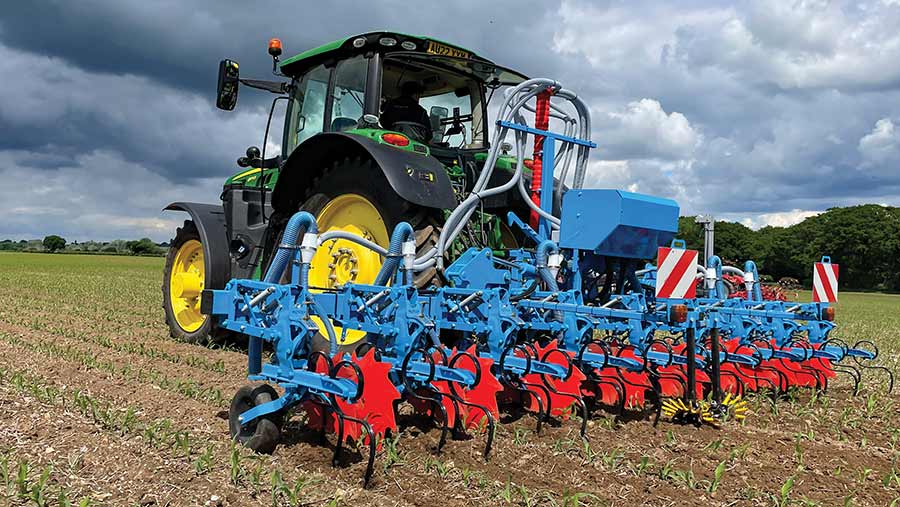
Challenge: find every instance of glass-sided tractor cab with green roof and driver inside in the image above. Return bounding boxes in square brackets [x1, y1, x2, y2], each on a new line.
[280, 32, 526, 158]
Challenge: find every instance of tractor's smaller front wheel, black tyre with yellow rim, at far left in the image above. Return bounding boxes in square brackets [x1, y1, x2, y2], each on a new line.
[162, 220, 215, 343]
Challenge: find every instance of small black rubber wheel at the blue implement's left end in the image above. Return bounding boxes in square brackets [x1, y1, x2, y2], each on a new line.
[228, 384, 281, 454]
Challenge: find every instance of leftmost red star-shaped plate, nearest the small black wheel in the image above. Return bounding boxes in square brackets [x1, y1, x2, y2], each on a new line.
[304, 349, 400, 443]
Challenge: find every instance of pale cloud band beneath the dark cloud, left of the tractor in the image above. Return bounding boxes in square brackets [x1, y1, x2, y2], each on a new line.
[0, 151, 222, 241]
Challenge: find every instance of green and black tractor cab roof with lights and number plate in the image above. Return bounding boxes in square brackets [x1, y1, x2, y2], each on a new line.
[281, 32, 527, 84]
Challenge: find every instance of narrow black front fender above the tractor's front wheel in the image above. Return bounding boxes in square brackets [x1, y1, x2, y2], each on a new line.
[163, 202, 231, 289]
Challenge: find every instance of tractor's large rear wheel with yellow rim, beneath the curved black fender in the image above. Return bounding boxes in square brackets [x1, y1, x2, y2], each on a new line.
[276, 158, 443, 352]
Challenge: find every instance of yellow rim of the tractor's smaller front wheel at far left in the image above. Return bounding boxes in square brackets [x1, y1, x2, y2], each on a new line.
[169, 239, 206, 333]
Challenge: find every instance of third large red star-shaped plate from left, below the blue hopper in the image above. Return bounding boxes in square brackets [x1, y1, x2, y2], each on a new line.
[522, 340, 587, 418]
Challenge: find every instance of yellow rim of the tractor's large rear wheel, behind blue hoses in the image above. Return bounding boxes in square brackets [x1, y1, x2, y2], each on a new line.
[309, 194, 390, 345]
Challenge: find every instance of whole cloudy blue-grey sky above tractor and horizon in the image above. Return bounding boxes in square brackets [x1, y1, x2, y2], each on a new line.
[0, 0, 900, 241]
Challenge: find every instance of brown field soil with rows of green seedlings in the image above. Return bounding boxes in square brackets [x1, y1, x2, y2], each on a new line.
[0, 254, 900, 507]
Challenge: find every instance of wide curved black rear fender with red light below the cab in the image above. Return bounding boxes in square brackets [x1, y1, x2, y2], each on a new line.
[272, 132, 456, 214]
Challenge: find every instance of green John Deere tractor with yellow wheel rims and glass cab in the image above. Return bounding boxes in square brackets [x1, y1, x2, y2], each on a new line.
[162, 32, 528, 347]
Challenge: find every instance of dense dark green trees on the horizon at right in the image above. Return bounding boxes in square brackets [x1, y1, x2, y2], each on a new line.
[678, 204, 900, 292]
